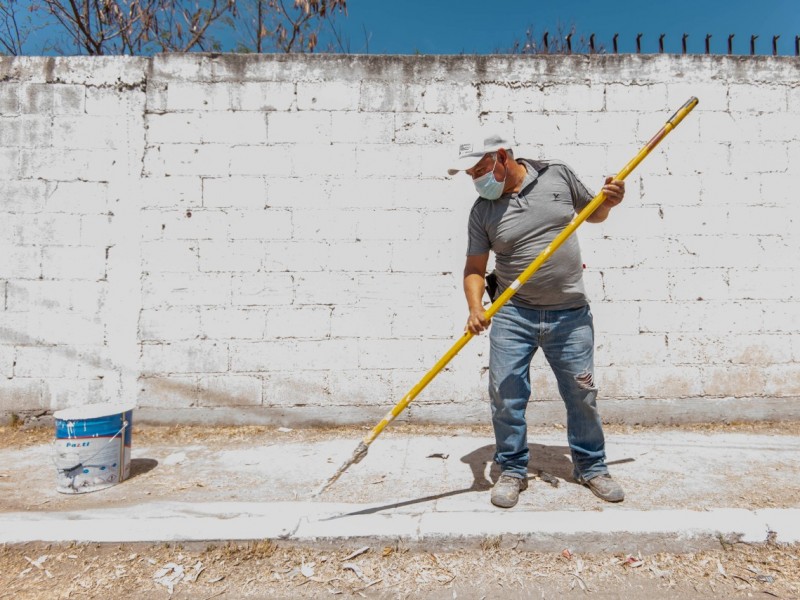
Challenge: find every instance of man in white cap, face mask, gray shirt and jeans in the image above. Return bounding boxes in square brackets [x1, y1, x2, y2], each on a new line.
[448, 135, 625, 508]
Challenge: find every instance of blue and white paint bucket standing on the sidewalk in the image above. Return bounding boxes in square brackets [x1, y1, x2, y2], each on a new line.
[53, 403, 135, 494]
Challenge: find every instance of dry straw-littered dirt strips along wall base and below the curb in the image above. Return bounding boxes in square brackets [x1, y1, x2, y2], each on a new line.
[0, 423, 800, 600]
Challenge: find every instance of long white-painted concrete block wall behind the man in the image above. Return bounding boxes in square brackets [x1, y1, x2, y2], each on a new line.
[0, 54, 800, 425]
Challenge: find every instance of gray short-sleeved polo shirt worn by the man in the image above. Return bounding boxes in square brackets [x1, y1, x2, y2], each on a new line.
[467, 159, 594, 310]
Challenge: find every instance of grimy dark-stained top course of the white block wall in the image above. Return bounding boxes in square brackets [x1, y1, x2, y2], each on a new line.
[0, 53, 800, 87]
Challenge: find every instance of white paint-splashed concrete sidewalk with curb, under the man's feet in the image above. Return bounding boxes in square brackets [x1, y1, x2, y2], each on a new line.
[0, 425, 800, 552]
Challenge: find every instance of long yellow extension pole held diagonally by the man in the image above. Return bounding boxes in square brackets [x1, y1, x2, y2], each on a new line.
[314, 97, 698, 496]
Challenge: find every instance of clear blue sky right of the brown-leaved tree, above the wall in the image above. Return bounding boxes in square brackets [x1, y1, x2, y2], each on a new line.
[324, 0, 800, 55]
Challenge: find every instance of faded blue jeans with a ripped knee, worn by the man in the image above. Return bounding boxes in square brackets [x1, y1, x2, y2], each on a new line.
[489, 304, 608, 482]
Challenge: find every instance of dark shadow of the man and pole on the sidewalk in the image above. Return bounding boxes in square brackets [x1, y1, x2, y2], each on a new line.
[321, 444, 634, 521]
